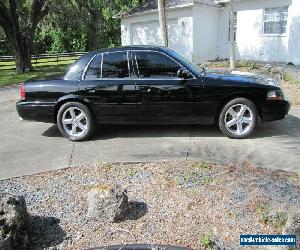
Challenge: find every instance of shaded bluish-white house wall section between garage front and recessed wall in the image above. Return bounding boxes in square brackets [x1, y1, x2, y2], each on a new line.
[193, 4, 219, 64]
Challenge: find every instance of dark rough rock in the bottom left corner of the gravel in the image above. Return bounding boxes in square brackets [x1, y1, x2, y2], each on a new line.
[0, 194, 32, 250]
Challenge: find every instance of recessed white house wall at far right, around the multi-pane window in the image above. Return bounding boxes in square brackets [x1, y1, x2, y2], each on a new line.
[219, 0, 300, 64]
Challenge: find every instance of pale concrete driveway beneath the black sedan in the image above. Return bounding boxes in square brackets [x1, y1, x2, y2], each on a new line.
[0, 86, 300, 179]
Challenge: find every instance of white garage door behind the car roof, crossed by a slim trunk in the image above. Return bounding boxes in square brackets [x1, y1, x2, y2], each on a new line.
[131, 19, 181, 52]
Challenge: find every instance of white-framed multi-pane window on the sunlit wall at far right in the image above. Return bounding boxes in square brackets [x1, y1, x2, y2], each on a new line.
[264, 6, 289, 35]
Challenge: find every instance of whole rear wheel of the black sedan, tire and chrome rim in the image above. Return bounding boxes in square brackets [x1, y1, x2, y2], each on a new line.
[57, 102, 95, 141]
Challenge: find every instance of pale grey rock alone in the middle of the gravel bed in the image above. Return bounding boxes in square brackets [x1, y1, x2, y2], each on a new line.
[87, 185, 128, 222]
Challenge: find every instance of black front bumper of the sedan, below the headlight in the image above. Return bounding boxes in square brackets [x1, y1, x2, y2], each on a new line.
[262, 100, 291, 122]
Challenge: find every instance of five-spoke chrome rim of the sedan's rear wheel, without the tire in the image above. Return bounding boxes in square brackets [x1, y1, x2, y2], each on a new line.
[62, 107, 88, 137]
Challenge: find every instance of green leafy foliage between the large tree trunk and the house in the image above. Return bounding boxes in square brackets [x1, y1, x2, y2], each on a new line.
[29, 0, 141, 54]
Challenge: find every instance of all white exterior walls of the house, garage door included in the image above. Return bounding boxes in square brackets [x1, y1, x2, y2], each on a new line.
[121, 0, 300, 64]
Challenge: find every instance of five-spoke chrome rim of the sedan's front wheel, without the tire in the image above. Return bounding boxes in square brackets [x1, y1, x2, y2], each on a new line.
[224, 104, 254, 136]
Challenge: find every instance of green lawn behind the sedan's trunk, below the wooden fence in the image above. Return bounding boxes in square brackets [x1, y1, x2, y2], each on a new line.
[0, 59, 74, 86]
